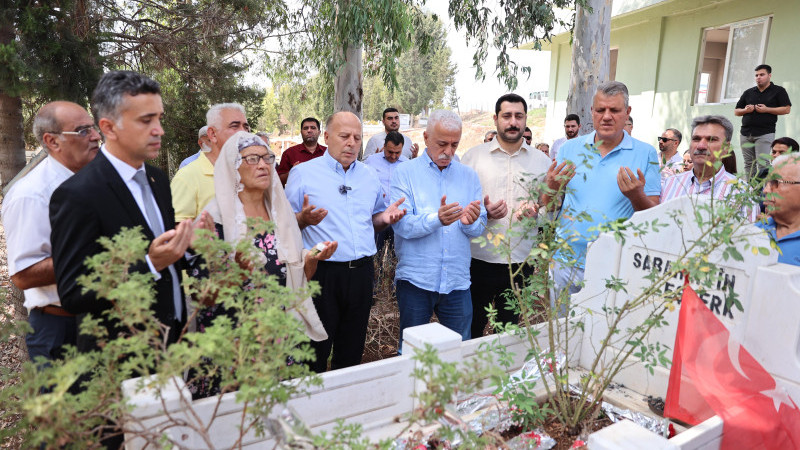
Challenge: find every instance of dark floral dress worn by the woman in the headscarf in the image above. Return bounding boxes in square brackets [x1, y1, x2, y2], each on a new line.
[189, 223, 286, 400]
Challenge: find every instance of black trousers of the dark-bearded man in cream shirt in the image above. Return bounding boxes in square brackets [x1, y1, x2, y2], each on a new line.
[469, 258, 533, 339]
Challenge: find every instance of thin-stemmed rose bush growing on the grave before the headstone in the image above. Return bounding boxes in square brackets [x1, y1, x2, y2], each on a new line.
[475, 143, 769, 435]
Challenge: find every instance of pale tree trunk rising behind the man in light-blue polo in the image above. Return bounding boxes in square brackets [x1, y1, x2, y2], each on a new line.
[567, 0, 612, 134]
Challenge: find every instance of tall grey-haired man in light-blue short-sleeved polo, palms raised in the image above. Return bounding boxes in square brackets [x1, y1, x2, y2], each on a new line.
[542, 81, 661, 293]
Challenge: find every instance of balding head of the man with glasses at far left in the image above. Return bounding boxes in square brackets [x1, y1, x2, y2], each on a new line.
[33, 101, 100, 172]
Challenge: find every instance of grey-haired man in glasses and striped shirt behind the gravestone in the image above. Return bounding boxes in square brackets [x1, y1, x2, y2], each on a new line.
[661, 115, 756, 222]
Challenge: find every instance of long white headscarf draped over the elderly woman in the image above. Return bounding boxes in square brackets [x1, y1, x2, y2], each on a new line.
[205, 131, 328, 341]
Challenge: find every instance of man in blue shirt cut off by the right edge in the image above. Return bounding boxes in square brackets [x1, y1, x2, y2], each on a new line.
[758, 153, 800, 266]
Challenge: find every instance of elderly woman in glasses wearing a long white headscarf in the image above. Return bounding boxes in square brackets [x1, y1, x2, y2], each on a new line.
[197, 131, 337, 341]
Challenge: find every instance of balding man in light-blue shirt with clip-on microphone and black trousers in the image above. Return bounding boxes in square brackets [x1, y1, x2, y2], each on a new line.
[286, 112, 405, 372]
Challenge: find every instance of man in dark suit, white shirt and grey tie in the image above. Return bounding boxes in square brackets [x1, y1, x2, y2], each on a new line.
[50, 71, 208, 351]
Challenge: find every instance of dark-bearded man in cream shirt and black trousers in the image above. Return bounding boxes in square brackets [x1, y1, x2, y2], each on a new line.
[461, 94, 551, 338]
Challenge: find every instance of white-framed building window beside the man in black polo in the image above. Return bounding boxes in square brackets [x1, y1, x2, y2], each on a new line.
[695, 16, 772, 104]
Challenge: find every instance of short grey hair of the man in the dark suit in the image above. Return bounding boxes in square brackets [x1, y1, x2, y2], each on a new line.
[91, 70, 161, 122]
